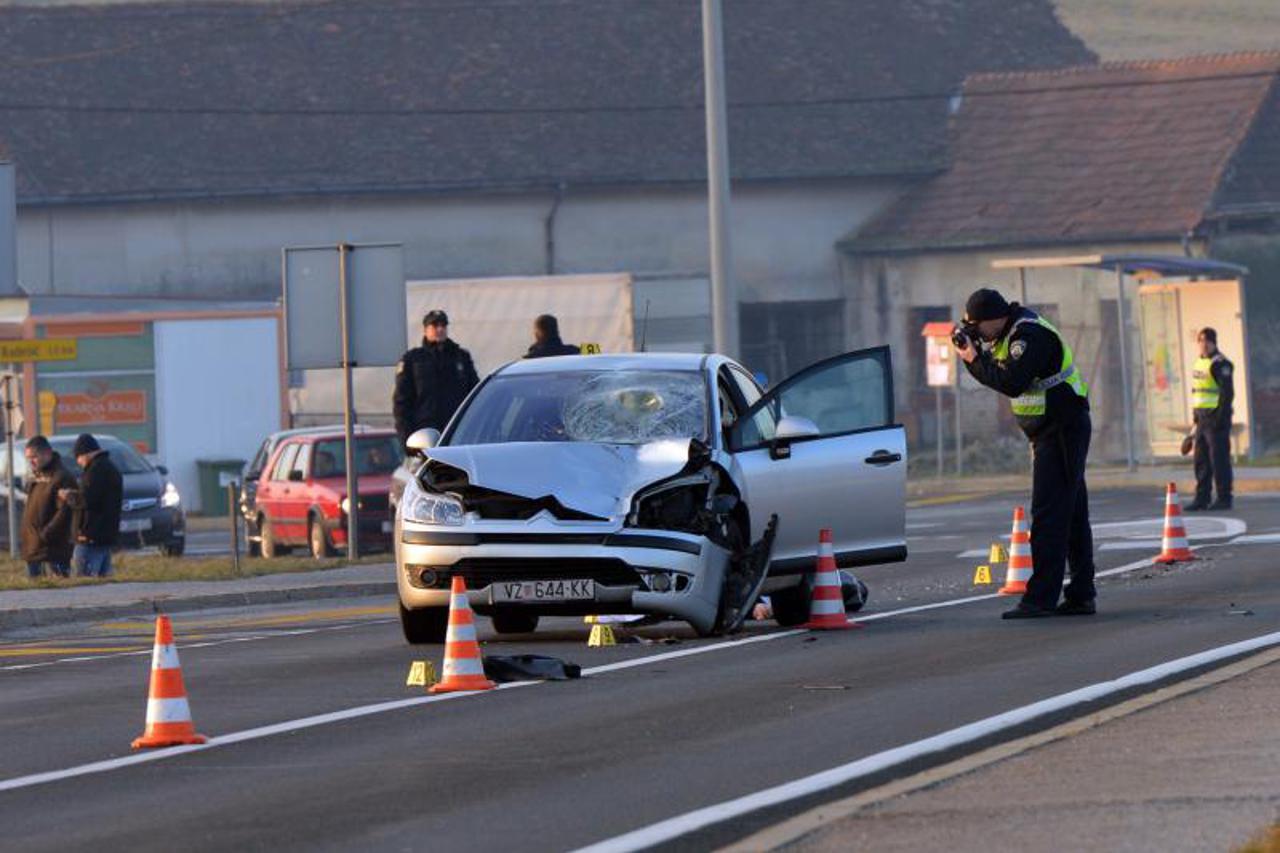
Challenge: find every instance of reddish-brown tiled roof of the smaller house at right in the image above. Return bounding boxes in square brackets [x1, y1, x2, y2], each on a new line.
[846, 53, 1280, 250]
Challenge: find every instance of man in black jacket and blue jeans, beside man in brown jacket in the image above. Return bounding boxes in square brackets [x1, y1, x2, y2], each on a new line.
[70, 433, 124, 578]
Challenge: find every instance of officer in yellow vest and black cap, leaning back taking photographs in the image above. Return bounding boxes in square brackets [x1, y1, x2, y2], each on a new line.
[952, 288, 1097, 619]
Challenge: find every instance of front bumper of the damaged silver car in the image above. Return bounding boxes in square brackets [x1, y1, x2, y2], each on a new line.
[394, 523, 730, 630]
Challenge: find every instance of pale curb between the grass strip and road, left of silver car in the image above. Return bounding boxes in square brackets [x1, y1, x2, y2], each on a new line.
[0, 581, 396, 631]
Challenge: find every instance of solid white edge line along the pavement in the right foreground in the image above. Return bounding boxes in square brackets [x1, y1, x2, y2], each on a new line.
[576, 631, 1280, 853]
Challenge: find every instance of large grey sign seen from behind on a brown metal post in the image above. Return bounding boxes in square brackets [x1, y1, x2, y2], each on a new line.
[282, 243, 407, 560]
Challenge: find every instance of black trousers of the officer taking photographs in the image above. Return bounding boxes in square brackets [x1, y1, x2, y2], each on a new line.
[1023, 412, 1097, 608]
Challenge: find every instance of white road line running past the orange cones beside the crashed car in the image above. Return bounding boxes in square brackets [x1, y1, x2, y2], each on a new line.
[0, 550, 1213, 792]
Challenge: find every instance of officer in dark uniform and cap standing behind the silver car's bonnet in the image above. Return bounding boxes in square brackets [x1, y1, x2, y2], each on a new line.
[392, 310, 480, 444]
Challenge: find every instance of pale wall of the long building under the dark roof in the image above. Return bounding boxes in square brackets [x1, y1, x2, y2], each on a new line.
[18, 179, 901, 308]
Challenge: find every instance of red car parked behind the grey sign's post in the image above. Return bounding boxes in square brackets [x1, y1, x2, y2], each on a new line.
[257, 430, 404, 558]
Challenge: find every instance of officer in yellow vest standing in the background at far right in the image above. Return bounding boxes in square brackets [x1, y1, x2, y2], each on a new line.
[1183, 327, 1235, 511]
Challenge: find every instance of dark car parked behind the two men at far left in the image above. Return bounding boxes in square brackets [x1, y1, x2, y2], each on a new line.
[0, 435, 187, 557]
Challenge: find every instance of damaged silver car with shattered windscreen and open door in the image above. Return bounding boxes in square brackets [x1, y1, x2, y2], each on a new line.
[393, 347, 906, 643]
